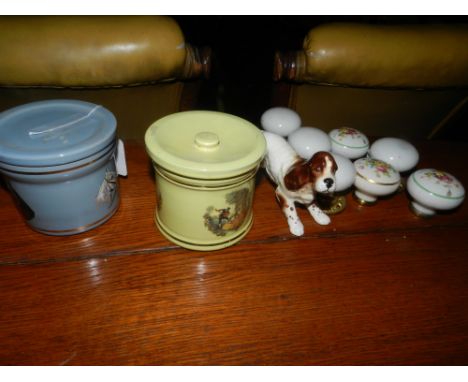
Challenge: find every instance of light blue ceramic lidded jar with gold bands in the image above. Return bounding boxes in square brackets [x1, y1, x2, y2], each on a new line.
[0, 100, 120, 235]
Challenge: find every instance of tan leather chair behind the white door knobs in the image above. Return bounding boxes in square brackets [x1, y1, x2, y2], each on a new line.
[274, 23, 468, 139]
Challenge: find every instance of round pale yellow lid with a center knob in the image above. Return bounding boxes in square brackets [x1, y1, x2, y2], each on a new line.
[145, 111, 266, 179]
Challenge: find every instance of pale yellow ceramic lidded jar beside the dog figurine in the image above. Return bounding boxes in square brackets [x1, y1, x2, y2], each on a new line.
[145, 111, 266, 251]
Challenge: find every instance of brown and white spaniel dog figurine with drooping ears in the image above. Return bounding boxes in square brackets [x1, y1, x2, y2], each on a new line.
[263, 131, 338, 236]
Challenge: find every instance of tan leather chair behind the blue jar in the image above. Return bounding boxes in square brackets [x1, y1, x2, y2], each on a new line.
[0, 16, 210, 140]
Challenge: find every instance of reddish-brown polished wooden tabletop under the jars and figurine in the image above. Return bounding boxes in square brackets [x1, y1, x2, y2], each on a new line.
[0, 142, 468, 365]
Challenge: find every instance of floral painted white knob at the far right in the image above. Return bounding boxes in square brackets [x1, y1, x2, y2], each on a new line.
[407, 169, 465, 217]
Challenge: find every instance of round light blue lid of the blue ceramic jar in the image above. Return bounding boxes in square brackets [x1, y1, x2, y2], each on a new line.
[0, 100, 117, 167]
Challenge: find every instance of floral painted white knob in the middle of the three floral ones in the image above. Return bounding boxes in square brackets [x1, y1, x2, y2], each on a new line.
[354, 158, 400, 205]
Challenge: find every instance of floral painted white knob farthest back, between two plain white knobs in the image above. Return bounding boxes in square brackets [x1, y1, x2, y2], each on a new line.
[329, 127, 369, 159]
